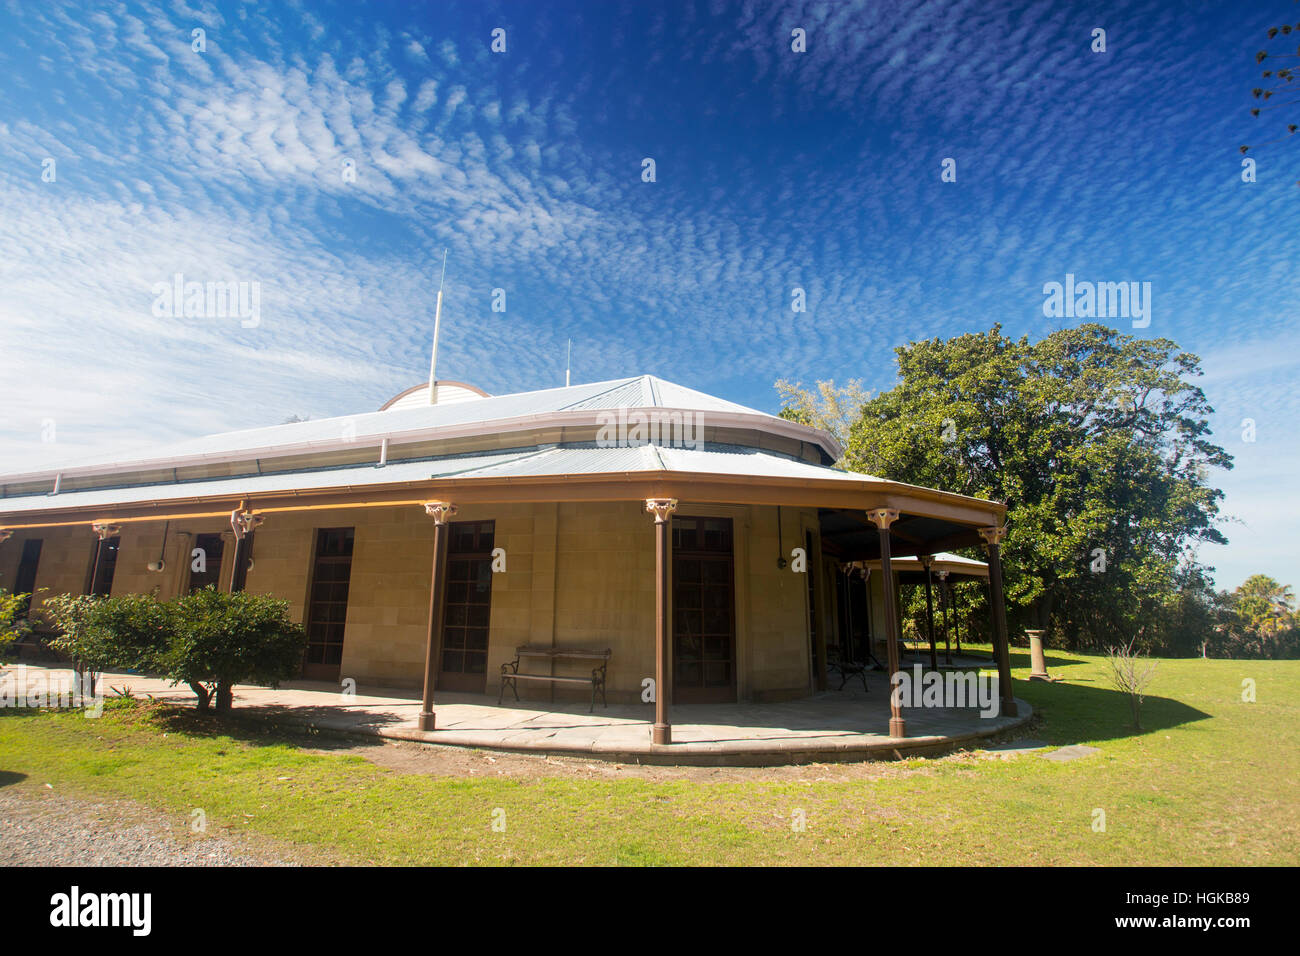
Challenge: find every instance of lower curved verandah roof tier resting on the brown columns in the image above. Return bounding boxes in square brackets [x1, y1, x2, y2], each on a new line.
[0, 445, 1005, 559]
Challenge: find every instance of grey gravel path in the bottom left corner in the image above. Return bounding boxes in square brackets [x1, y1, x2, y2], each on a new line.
[0, 787, 295, 866]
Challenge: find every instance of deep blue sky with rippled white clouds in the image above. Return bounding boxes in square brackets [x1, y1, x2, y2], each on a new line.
[0, 0, 1300, 587]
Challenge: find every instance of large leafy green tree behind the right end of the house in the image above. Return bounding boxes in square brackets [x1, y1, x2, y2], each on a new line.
[845, 324, 1232, 645]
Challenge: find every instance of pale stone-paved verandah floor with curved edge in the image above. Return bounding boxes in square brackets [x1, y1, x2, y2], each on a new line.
[4, 665, 1031, 763]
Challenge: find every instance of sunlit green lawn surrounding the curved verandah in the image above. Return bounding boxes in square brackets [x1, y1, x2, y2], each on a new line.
[0, 652, 1300, 865]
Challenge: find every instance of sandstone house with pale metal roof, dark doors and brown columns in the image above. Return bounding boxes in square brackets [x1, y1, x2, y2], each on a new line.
[0, 376, 1015, 744]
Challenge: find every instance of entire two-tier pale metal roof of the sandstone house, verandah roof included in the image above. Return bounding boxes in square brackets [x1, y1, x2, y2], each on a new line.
[0, 376, 1005, 561]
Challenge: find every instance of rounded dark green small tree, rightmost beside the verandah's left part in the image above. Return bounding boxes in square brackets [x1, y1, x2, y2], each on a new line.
[163, 588, 307, 713]
